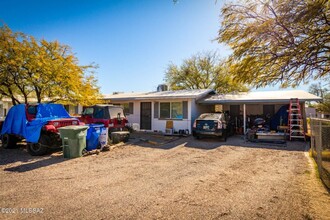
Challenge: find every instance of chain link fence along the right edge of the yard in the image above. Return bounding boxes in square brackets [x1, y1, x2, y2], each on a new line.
[310, 118, 330, 189]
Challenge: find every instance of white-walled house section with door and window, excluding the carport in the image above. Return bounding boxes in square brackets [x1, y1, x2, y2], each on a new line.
[104, 89, 215, 132]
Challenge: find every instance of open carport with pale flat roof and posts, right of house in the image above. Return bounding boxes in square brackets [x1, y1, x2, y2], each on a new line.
[198, 90, 322, 134]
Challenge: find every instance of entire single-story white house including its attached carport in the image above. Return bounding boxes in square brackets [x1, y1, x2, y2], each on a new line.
[104, 89, 321, 133]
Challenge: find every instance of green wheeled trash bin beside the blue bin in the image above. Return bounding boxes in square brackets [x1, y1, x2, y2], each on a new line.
[58, 125, 88, 158]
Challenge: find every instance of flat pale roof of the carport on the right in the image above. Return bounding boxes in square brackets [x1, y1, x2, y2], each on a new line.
[198, 90, 322, 104]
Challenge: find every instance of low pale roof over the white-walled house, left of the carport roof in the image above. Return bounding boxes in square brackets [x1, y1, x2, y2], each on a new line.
[103, 89, 215, 101]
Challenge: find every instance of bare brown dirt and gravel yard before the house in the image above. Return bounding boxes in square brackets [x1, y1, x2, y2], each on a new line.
[0, 134, 330, 219]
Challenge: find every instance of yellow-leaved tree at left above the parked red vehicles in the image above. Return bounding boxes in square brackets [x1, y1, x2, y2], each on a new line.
[0, 26, 100, 105]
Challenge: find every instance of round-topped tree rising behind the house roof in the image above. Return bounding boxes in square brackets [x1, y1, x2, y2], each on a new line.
[165, 52, 248, 93]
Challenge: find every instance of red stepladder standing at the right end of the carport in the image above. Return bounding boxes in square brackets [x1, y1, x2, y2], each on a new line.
[288, 98, 306, 141]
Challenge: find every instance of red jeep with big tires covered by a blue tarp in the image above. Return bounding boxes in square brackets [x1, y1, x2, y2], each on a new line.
[1, 104, 80, 156]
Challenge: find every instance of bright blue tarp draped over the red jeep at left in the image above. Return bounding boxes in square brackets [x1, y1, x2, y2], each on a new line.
[1, 104, 71, 143]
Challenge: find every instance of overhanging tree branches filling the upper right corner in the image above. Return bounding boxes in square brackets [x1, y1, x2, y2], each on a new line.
[218, 0, 330, 87]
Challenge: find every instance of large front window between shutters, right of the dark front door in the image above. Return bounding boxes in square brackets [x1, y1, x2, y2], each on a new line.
[159, 102, 183, 119]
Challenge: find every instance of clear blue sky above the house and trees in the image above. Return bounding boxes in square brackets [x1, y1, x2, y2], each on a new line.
[0, 0, 308, 94]
